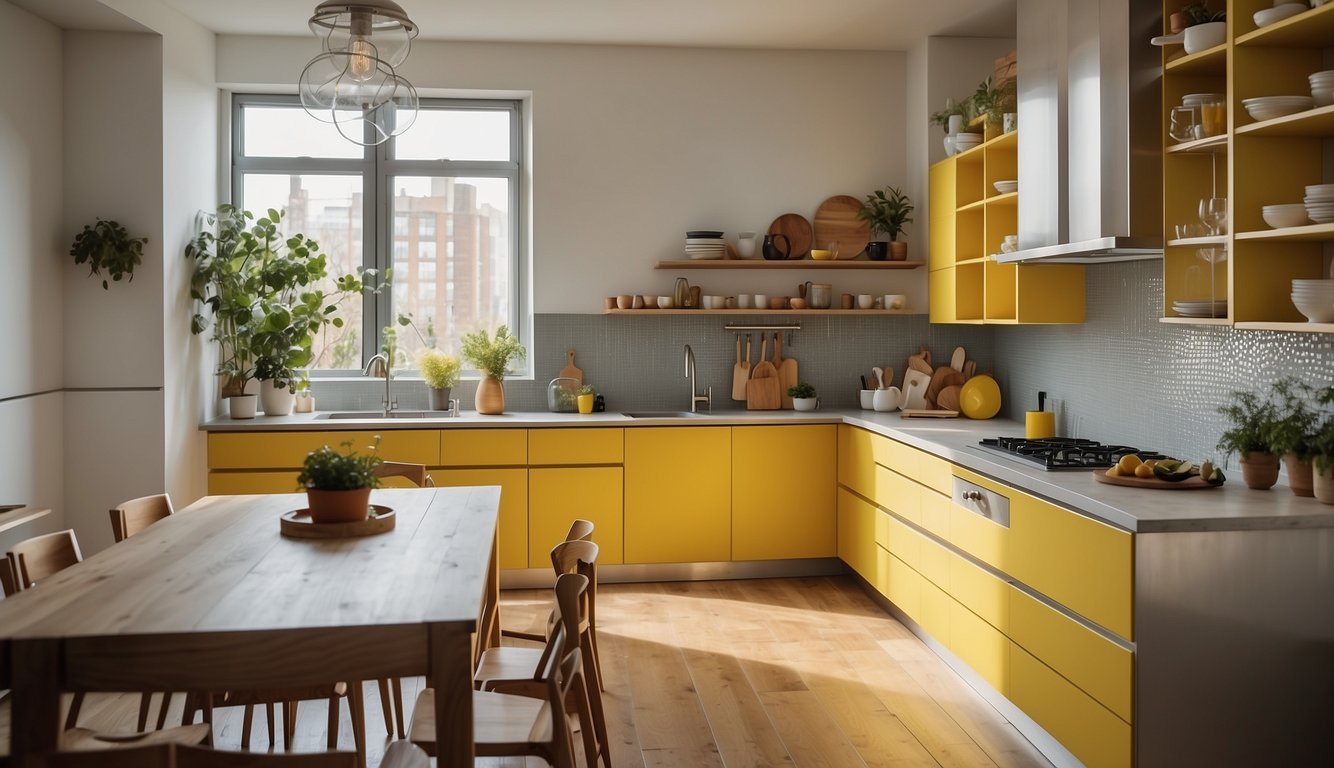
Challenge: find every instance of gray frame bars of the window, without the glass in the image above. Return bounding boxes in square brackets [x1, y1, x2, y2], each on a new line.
[228, 93, 532, 379]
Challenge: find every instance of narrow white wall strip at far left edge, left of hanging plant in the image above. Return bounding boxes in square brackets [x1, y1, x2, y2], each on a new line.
[0, 0, 69, 552]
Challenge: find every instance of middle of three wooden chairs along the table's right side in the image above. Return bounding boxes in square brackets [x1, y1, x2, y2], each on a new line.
[474, 540, 611, 768]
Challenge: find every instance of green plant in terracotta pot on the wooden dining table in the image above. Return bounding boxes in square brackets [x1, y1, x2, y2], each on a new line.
[296, 435, 384, 523]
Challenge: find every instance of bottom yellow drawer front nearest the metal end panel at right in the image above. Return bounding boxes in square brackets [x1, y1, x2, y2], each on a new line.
[1007, 644, 1136, 768]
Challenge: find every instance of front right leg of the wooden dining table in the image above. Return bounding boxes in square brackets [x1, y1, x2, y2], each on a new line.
[431, 624, 474, 768]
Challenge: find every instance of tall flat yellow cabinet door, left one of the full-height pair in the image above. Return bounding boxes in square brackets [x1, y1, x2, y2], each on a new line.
[626, 427, 732, 563]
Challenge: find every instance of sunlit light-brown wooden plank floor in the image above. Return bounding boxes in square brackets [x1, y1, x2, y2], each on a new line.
[0, 577, 1049, 768]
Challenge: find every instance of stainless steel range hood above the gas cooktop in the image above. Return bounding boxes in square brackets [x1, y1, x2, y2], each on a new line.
[994, 0, 1163, 264]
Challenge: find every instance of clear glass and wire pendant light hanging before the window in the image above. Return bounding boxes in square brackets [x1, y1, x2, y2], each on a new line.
[300, 0, 418, 147]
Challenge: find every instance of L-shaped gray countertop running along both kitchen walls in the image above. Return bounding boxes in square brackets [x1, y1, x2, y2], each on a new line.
[201, 411, 1334, 533]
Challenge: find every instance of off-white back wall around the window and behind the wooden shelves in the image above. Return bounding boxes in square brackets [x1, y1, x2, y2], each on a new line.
[217, 36, 926, 313]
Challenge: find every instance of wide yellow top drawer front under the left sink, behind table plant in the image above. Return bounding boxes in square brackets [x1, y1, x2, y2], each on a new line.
[208, 429, 440, 469]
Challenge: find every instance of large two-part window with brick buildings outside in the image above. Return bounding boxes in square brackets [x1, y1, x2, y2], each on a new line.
[232, 95, 531, 369]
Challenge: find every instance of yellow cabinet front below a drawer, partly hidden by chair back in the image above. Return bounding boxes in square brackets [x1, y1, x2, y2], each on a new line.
[528, 467, 624, 568]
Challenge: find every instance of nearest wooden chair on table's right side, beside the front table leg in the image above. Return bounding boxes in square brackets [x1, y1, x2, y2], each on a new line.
[411, 573, 590, 768]
